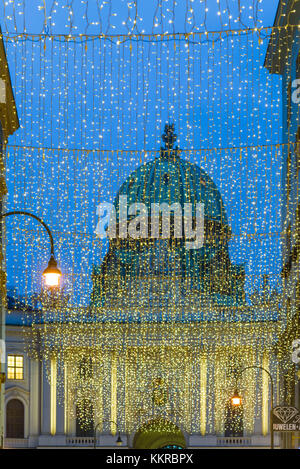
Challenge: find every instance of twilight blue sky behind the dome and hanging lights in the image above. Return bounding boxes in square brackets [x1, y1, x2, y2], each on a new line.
[0, 0, 281, 305]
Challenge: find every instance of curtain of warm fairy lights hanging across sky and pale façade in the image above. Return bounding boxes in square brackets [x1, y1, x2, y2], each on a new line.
[3, 2, 290, 433]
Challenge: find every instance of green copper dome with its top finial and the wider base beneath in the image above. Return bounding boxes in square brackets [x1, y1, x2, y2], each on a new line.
[92, 125, 245, 314]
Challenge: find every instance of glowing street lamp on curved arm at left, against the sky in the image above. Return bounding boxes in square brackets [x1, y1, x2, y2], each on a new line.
[0, 210, 62, 288]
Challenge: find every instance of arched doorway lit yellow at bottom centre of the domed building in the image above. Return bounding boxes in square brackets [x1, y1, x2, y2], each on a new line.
[133, 418, 186, 449]
